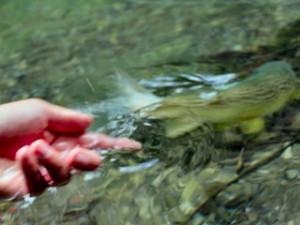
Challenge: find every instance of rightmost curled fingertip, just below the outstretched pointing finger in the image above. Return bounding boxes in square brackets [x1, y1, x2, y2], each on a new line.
[66, 147, 101, 171]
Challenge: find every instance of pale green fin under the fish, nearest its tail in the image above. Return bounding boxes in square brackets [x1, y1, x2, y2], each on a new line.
[164, 119, 201, 138]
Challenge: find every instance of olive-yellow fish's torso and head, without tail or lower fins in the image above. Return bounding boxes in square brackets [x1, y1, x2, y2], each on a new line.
[149, 61, 297, 123]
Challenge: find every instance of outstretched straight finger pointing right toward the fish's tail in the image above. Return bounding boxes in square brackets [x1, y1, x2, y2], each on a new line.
[78, 133, 142, 150]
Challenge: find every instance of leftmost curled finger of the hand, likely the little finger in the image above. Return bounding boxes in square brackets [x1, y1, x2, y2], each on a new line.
[16, 146, 49, 195]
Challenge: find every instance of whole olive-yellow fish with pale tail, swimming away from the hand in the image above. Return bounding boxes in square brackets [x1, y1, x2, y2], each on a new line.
[118, 61, 300, 138]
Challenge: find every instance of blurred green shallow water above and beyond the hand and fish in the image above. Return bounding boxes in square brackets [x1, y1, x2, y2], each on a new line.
[0, 0, 300, 105]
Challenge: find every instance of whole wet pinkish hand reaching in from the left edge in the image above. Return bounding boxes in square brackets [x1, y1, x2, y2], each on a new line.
[0, 99, 141, 199]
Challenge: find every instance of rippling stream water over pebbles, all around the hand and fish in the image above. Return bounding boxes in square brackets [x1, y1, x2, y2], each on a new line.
[0, 0, 300, 225]
